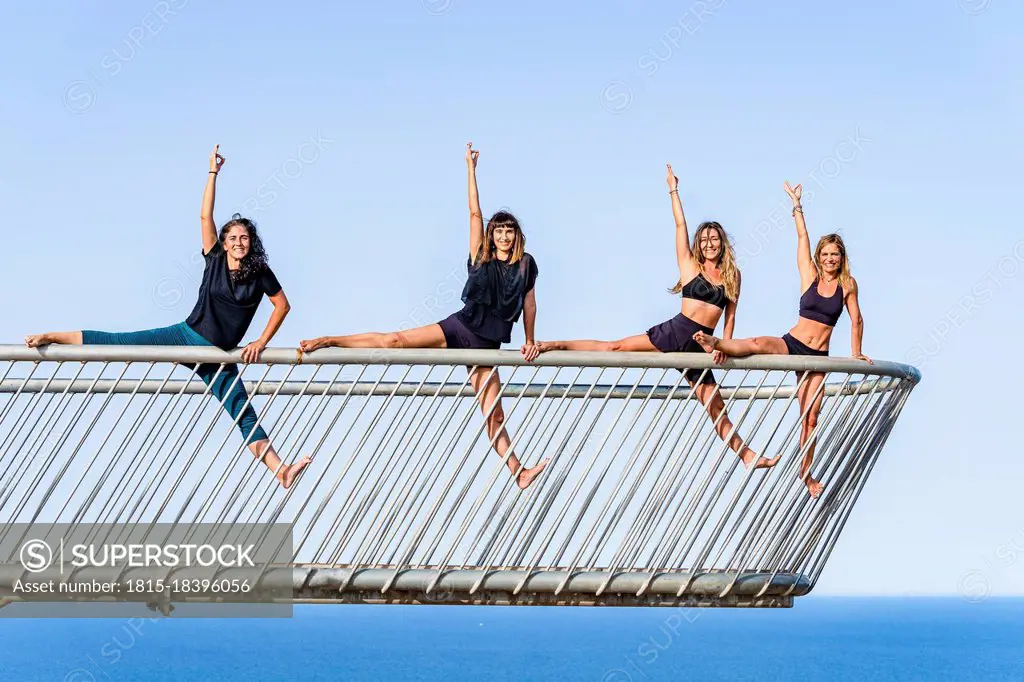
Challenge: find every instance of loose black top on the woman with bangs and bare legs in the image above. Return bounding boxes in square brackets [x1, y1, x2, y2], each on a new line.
[458, 253, 539, 342]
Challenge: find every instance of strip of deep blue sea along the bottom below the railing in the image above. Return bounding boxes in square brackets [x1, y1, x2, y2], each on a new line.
[0, 597, 1024, 682]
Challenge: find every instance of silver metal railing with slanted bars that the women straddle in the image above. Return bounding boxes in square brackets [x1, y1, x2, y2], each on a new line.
[0, 346, 920, 605]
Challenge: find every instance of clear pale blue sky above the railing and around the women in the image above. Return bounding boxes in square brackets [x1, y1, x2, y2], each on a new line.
[0, 0, 1024, 594]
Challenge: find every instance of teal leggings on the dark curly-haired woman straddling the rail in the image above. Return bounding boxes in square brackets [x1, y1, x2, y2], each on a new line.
[82, 323, 268, 444]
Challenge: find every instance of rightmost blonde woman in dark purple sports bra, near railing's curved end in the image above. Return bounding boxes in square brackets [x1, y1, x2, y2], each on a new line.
[693, 182, 871, 499]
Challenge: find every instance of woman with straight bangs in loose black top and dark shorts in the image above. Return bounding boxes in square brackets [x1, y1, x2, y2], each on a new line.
[299, 142, 548, 488]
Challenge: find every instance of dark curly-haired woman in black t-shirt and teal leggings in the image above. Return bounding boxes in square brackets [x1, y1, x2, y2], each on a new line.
[25, 145, 309, 488]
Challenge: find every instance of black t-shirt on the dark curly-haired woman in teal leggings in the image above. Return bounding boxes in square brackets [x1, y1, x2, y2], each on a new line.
[185, 242, 281, 350]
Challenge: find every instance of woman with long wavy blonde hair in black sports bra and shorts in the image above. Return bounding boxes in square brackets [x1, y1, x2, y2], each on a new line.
[538, 166, 778, 469]
